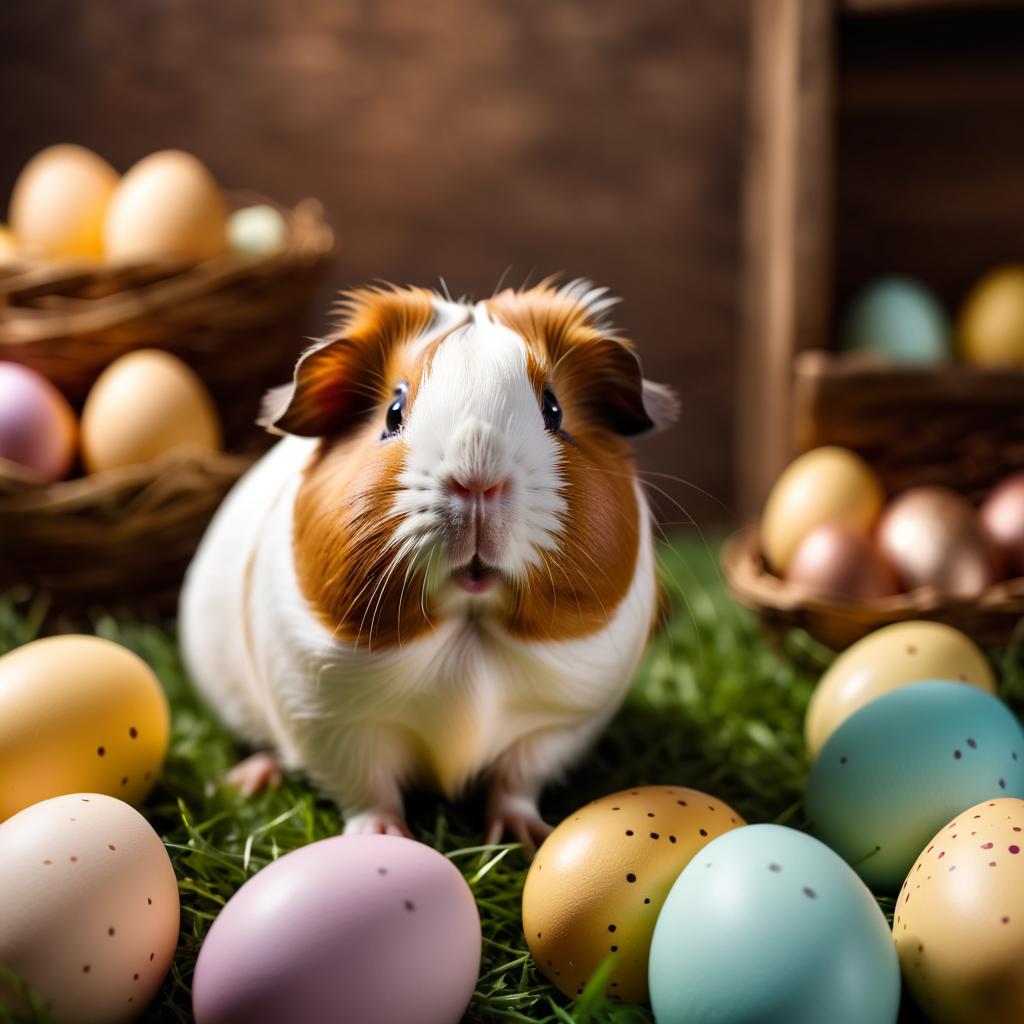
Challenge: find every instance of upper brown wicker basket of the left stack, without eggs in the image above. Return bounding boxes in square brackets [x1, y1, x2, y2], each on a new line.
[0, 194, 334, 449]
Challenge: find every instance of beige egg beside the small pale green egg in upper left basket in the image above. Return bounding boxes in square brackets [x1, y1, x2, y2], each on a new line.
[103, 150, 227, 263]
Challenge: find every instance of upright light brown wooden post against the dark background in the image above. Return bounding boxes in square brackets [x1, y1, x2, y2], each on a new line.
[736, 0, 836, 518]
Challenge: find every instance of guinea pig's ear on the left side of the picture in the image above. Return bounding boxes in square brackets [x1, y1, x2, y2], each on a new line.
[256, 338, 367, 437]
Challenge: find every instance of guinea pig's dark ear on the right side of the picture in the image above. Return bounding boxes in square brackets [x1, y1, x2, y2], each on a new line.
[564, 338, 679, 437]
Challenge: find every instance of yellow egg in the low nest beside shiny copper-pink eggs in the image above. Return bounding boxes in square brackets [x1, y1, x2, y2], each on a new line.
[761, 445, 883, 573]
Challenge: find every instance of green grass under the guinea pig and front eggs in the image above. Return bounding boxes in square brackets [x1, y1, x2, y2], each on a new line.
[0, 538, 1024, 1024]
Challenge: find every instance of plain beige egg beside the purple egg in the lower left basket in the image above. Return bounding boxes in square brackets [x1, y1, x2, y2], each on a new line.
[81, 348, 221, 473]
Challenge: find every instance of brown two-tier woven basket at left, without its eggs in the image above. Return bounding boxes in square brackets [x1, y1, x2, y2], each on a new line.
[0, 195, 334, 611]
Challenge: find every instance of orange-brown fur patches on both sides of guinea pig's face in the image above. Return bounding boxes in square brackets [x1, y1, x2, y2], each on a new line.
[294, 283, 644, 649]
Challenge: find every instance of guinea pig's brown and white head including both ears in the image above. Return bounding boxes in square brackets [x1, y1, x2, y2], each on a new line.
[261, 281, 676, 649]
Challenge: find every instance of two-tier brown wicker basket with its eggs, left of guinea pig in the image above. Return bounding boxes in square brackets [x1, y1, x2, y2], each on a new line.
[0, 145, 333, 610]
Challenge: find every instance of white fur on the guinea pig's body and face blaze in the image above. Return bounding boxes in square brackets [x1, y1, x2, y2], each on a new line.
[180, 284, 657, 843]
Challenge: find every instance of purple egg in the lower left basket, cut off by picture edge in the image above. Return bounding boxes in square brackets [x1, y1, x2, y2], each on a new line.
[0, 362, 78, 481]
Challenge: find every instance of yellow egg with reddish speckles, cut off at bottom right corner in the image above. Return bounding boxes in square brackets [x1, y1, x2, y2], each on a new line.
[893, 797, 1024, 1024]
